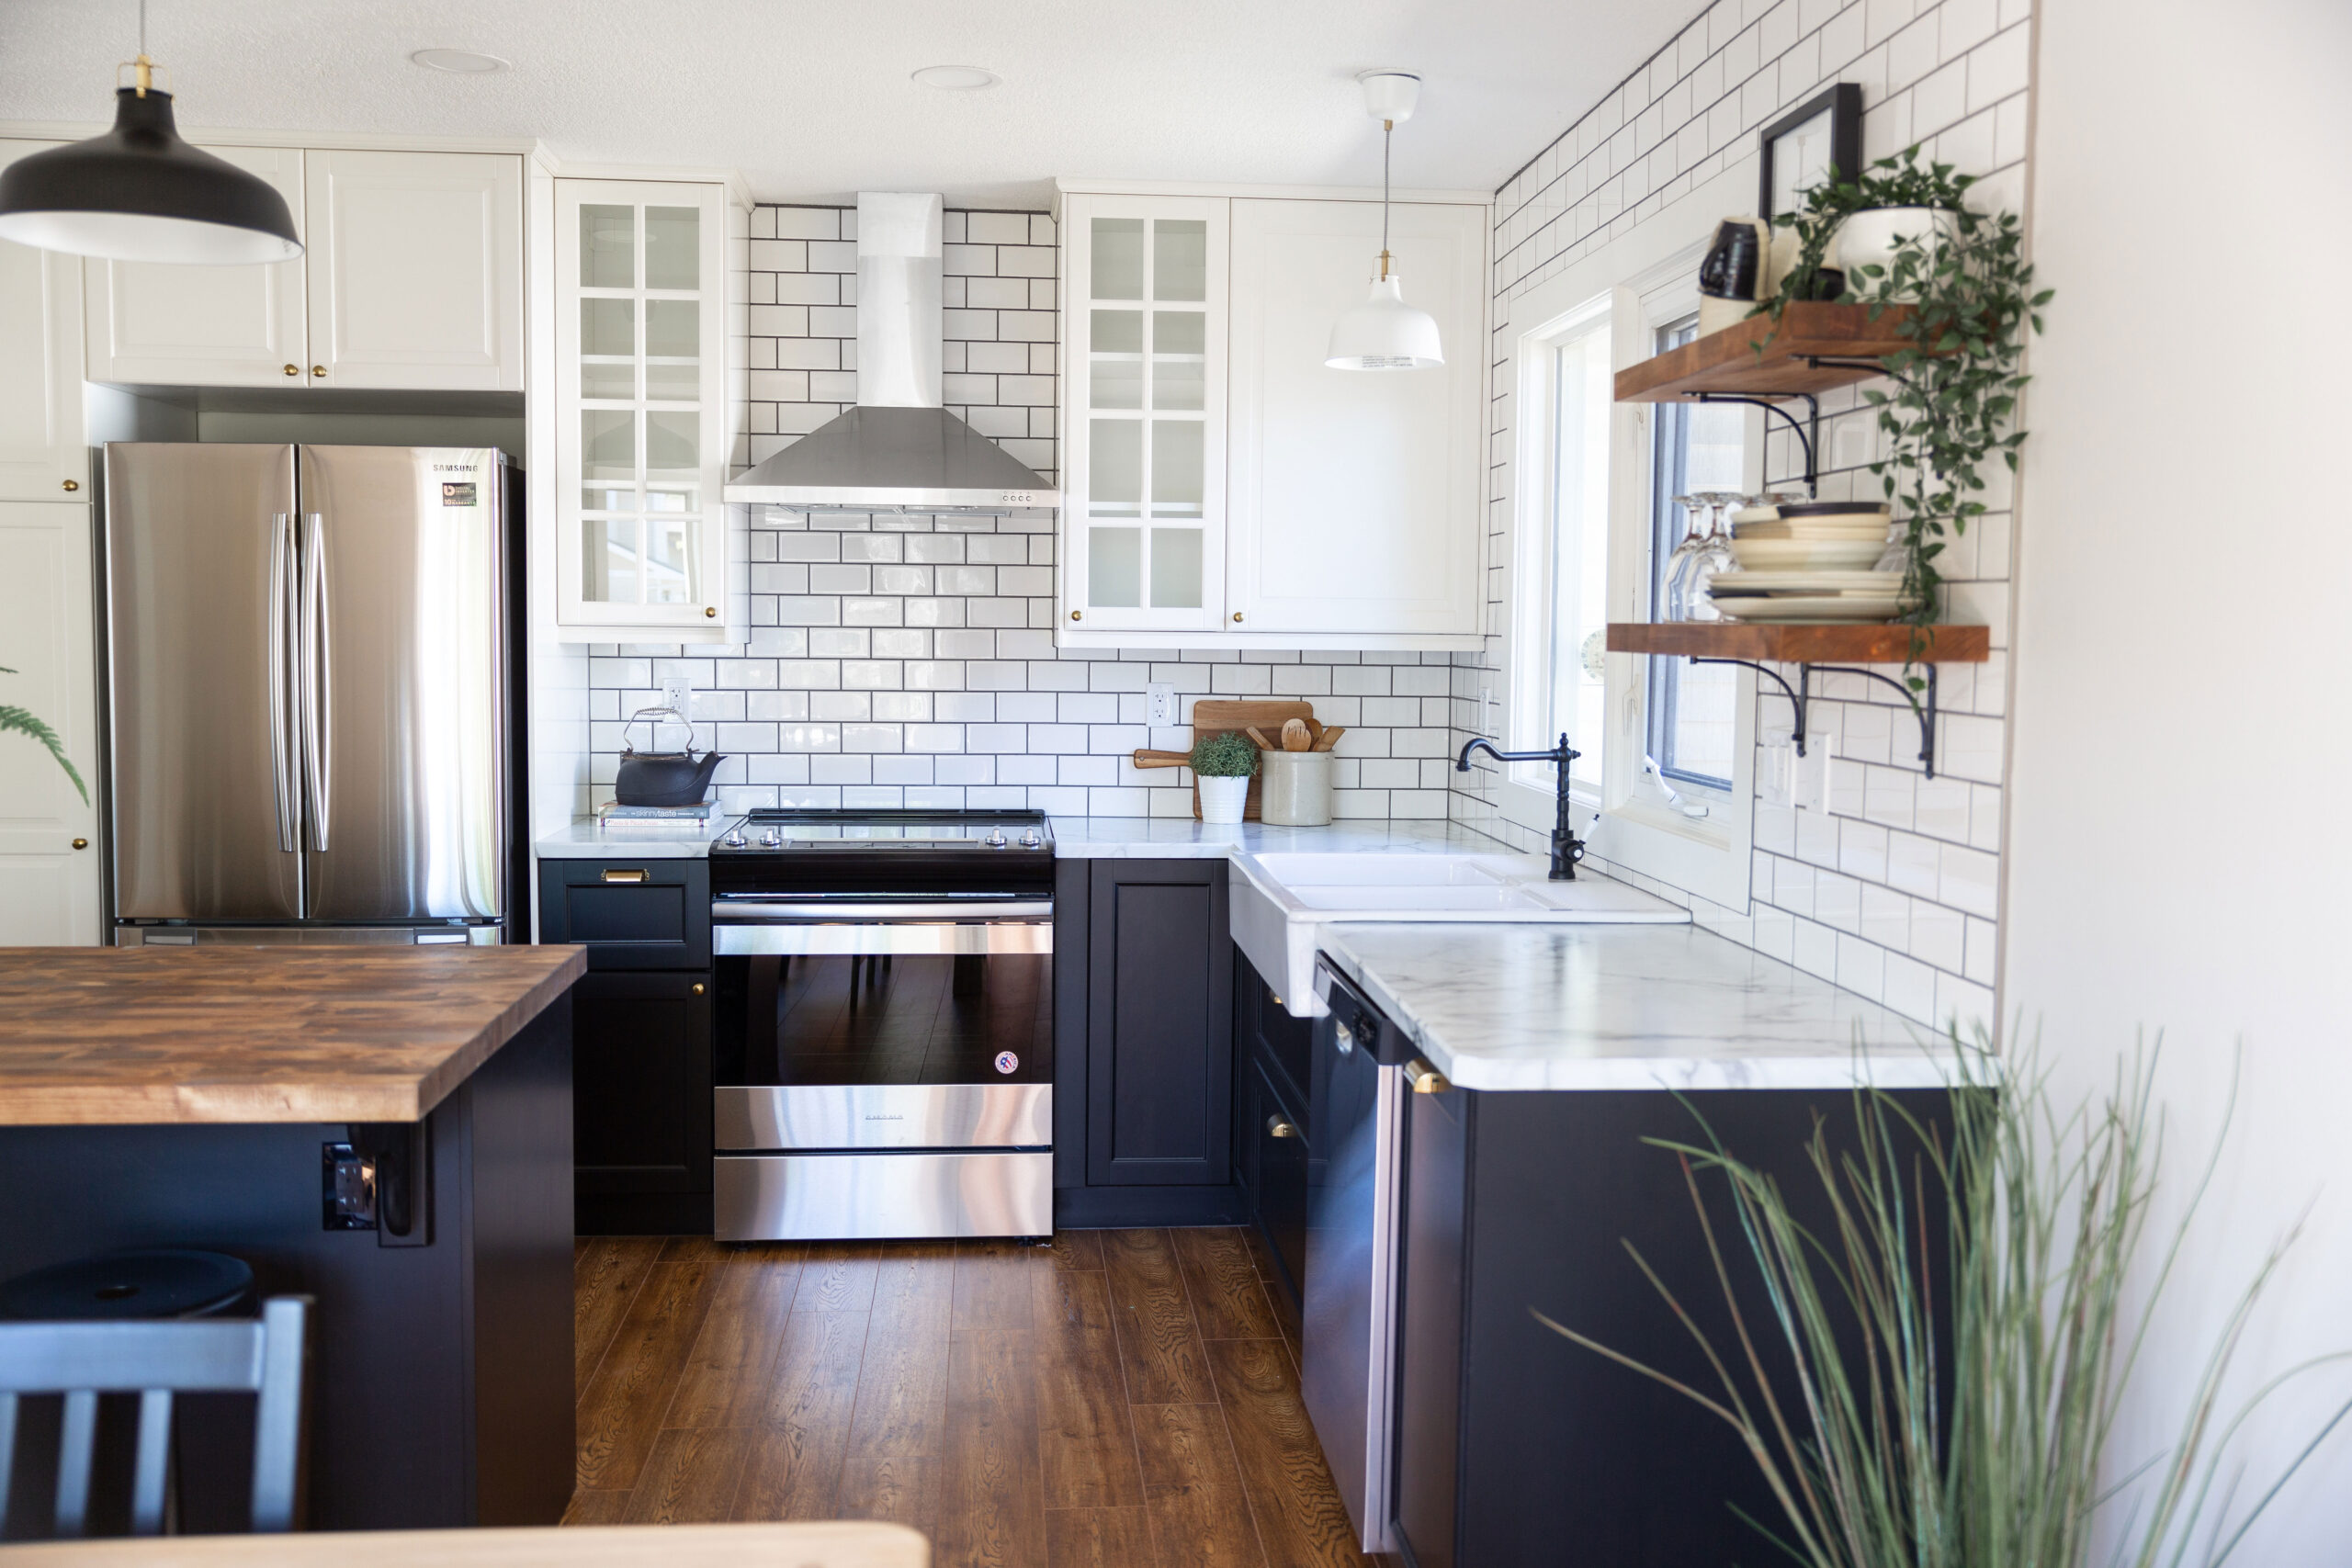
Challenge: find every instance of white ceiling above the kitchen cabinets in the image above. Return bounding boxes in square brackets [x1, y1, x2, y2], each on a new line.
[0, 0, 1701, 207]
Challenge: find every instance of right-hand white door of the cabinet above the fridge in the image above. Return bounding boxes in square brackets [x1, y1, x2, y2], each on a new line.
[303, 151, 522, 392]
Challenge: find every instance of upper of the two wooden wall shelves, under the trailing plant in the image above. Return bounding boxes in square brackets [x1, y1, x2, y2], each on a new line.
[1616, 301, 1917, 402]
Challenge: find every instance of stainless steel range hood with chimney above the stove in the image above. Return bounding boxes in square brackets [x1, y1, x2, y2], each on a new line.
[724, 193, 1061, 513]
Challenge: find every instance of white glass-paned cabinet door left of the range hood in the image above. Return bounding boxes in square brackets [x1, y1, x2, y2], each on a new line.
[555, 179, 729, 642]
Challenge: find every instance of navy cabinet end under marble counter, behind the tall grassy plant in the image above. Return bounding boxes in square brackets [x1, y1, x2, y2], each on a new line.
[1393, 1089, 1950, 1568]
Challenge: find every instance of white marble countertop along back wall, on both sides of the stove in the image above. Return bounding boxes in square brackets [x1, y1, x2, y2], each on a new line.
[534, 816, 1508, 861]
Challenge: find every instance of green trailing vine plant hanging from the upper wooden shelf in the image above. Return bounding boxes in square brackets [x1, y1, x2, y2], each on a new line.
[1767, 146, 2051, 689]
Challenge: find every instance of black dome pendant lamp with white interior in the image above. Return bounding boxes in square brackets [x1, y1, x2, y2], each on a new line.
[0, 0, 301, 265]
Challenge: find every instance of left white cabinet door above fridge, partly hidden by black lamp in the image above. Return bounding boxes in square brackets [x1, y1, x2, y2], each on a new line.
[85, 148, 311, 386]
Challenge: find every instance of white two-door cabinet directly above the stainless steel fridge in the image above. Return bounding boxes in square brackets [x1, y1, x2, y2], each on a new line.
[85, 146, 522, 392]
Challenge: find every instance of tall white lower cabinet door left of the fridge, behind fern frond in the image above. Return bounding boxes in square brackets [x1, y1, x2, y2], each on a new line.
[0, 501, 101, 947]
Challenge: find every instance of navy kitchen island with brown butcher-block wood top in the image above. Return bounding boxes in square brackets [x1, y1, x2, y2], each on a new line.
[0, 945, 585, 1528]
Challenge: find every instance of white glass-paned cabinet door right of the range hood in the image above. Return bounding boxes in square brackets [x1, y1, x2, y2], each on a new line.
[1061, 195, 1230, 632]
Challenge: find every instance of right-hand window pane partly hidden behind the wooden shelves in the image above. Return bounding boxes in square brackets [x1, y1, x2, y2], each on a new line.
[1646, 315, 1746, 792]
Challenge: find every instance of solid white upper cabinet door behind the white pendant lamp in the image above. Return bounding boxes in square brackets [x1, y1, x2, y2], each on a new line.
[1226, 200, 1487, 637]
